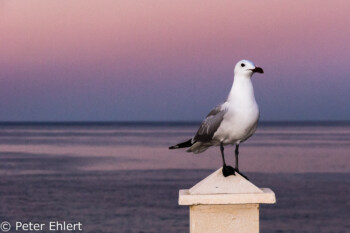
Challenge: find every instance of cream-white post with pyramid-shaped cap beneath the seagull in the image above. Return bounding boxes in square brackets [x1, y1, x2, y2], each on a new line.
[179, 168, 276, 233]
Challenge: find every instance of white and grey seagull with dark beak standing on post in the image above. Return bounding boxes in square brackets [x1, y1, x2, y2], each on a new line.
[169, 60, 264, 179]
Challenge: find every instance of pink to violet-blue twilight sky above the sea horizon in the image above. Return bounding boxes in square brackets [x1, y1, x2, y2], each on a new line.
[0, 0, 350, 121]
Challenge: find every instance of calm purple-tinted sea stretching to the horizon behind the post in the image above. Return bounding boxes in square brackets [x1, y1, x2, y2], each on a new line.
[0, 122, 350, 233]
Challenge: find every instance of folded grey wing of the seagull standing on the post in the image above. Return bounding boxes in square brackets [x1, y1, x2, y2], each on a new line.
[193, 105, 227, 142]
